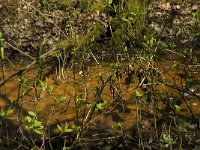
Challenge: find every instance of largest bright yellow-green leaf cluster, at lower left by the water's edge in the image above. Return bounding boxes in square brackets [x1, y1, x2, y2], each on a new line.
[25, 111, 44, 135]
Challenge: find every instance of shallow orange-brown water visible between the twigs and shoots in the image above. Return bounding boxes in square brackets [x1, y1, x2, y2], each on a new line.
[0, 62, 200, 135]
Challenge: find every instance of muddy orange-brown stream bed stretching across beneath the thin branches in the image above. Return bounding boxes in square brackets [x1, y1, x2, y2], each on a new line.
[0, 62, 200, 140]
